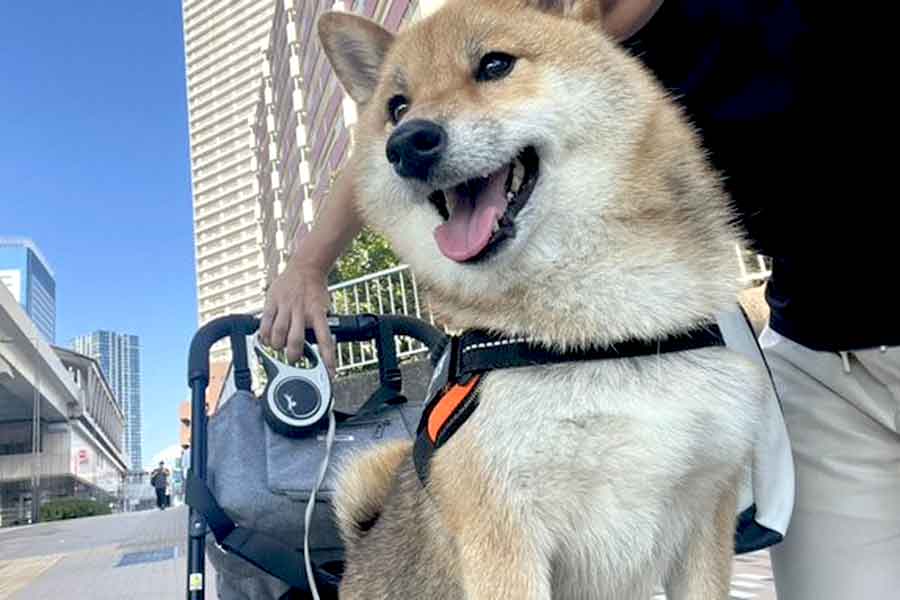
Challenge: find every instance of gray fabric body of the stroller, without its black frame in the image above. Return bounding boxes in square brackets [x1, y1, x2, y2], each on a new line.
[207, 391, 423, 600]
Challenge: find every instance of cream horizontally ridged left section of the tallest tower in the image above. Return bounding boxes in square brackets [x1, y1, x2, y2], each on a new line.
[182, 0, 277, 346]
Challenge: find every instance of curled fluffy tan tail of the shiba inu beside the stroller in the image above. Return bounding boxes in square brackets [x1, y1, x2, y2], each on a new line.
[335, 442, 412, 544]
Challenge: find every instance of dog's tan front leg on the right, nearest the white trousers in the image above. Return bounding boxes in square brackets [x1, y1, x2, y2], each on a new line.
[666, 481, 737, 600]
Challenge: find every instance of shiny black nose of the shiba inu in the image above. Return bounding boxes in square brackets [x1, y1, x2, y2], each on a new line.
[387, 119, 447, 181]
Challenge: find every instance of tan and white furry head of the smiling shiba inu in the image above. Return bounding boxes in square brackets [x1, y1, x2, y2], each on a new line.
[319, 0, 737, 347]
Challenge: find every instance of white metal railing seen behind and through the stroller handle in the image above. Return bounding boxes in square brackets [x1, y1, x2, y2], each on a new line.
[328, 265, 434, 372]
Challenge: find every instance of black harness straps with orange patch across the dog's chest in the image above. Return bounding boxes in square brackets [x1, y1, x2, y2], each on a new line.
[413, 323, 725, 485]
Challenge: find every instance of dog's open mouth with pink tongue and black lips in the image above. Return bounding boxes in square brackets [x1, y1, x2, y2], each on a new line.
[428, 146, 540, 262]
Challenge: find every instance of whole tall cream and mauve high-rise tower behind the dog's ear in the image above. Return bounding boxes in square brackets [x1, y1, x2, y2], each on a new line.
[182, 0, 439, 361]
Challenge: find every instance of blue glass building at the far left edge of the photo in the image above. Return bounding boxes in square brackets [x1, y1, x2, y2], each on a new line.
[0, 237, 56, 344]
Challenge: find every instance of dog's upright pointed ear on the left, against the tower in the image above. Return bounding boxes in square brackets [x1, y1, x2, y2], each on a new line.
[318, 11, 394, 105]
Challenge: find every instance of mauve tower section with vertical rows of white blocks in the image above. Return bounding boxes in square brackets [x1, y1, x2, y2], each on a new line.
[250, 0, 420, 281]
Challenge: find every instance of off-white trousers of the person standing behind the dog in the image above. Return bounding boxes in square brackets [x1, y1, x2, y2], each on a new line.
[761, 330, 900, 600]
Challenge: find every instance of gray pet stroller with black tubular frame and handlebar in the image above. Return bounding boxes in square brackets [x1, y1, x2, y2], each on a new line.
[185, 314, 447, 600]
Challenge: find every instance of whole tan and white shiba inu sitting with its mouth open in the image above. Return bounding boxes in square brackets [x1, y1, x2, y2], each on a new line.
[319, 0, 771, 600]
